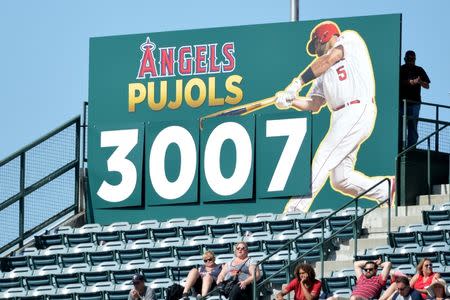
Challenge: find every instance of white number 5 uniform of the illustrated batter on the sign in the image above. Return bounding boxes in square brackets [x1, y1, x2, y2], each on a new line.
[285, 30, 390, 212]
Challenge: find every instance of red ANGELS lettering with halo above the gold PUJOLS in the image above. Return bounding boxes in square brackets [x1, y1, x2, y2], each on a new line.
[136, 37, 236, 79]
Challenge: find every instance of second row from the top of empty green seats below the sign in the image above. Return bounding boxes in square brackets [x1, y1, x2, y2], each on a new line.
[1, 229, 342, 271]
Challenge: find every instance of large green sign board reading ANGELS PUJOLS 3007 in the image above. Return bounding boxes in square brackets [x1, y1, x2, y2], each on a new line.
[88, 15, 401, 224]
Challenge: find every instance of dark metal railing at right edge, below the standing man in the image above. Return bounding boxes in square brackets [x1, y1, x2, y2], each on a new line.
[395, 122, 450, 206]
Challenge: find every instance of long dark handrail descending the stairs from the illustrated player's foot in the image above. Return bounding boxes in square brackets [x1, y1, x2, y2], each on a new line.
[201, 178, 392, 300]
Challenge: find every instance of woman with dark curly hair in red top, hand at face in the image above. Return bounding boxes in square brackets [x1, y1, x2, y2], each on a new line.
[277, 264, 322, 300]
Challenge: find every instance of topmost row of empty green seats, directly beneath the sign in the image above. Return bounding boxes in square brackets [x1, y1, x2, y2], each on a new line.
[36, 208, 364, 248]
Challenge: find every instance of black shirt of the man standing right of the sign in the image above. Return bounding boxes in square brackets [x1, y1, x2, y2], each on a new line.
[400, 64, 430, 102]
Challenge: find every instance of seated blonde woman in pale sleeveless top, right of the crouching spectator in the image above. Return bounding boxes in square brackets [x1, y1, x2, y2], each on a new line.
[217, 242, 260, 300]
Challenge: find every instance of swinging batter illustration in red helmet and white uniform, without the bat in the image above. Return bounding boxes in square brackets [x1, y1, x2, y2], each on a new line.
[275, 21, 395, 212]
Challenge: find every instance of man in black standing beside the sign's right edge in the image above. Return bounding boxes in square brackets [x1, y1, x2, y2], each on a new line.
[400, 50, 430, 147]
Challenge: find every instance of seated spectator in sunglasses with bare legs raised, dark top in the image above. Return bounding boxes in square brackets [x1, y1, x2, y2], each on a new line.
[183, 251, 222, 299]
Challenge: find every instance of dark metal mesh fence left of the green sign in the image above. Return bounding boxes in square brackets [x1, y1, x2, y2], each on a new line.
[0, 117, 80, 253]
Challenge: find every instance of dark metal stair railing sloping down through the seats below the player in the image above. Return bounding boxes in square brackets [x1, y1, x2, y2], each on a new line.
[202, 178, 392, 299]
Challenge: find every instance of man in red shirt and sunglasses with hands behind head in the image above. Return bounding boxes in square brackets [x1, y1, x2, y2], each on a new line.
[350, 258, 392, 300]
